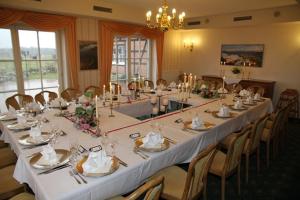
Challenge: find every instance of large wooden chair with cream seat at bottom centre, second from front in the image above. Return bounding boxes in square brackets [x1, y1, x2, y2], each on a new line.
[154, 145, 216, 200]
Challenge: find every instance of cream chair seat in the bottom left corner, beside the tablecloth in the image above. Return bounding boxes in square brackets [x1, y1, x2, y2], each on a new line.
[0, 165, 25, 200]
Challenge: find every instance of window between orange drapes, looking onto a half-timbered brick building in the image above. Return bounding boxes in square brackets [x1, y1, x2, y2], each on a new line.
[111, 36, 151, 87]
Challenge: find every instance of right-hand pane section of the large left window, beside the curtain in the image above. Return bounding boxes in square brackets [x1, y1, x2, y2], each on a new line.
[18, 30, 58, 96]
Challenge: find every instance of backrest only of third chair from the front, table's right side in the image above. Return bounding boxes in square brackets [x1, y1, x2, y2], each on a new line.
[223, 125, 252, 173]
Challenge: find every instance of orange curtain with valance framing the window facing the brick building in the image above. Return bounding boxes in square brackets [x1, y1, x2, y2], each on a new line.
[99, 21, 164, 88]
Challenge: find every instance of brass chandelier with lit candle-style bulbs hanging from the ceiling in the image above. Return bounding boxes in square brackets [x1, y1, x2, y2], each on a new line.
[146, 0, 185, 32]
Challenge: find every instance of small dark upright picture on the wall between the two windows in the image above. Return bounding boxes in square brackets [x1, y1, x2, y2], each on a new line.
[79, 41, 98, 70]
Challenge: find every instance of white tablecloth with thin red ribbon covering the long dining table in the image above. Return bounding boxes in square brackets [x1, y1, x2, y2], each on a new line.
[0, 92, 273, 200]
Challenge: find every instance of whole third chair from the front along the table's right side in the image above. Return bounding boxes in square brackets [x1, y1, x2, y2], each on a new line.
[209, 126, 252, 200]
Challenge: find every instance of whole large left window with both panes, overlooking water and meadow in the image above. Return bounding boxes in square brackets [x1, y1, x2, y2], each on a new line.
[0, 27, 60, 111]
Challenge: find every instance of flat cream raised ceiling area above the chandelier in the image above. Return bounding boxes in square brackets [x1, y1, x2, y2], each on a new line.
[101, 0, 297, 18]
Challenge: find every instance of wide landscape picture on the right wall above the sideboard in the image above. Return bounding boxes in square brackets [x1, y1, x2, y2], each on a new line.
[221, 44, 264, 67]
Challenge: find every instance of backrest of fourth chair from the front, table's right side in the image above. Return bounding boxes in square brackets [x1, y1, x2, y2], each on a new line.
[248, 114, 269, 151]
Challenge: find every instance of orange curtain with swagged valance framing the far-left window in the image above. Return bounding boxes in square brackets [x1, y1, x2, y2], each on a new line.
[0, 7, 79, 88]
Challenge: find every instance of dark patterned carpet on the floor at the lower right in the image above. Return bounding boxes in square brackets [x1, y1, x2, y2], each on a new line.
[181, 121, 300, 200]
